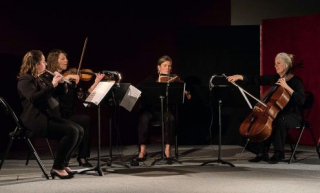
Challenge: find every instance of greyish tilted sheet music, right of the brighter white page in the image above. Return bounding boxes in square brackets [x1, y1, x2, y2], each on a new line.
[119, 85, 141, 111]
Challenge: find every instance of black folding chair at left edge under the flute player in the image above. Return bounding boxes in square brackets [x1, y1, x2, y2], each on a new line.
[0, 97, 50, 179]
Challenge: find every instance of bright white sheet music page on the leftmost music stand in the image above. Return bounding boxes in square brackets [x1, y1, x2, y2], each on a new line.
[85, 81, 115, 106]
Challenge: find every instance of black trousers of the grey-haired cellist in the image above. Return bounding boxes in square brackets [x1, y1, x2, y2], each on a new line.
[257, 112, 302, 153]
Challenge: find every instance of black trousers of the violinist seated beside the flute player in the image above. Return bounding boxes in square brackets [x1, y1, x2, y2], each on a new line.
[69, 114, 91, 158]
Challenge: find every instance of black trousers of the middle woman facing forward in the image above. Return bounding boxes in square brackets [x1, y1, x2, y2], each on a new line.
[138, 111, 175, 145]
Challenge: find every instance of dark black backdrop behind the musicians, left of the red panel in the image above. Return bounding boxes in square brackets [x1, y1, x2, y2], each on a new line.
[0, 1, 260, 151]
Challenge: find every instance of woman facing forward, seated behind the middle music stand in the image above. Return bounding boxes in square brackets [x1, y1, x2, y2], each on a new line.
[137, 55, 190, 164]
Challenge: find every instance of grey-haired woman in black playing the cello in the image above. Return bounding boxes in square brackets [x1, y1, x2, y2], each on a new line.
[227, 52, 305, 164]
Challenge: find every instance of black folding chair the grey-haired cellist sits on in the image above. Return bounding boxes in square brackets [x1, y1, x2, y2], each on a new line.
[288, 91, 320, 164]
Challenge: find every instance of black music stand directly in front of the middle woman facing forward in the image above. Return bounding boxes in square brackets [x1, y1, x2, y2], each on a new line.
[139, 82, 185, 166]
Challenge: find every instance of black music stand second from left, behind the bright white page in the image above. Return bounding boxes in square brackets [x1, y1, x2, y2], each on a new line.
[102, 83, 131, 168]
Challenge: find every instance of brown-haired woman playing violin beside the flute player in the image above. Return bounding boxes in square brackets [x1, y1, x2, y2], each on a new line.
[47, 49, 105, 167]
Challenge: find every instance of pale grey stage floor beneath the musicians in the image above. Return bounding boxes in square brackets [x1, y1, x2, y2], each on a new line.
[0, 145, 320, 193]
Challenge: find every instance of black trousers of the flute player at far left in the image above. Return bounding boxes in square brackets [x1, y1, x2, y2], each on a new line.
[46, 117, 84, 170]
